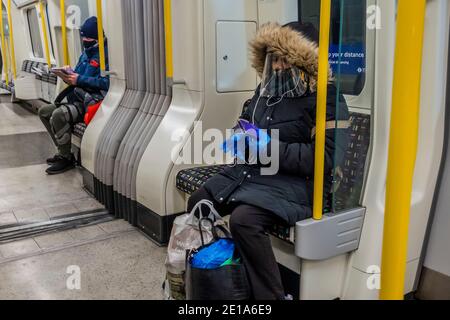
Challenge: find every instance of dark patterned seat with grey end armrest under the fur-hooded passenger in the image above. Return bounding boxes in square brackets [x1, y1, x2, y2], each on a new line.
[176, 113, 370, 260]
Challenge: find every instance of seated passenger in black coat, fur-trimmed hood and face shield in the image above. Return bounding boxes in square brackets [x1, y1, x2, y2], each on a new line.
[188, 23, 349, 300]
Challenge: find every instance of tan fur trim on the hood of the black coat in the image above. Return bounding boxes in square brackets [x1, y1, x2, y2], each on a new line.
[250, 23, 332, 92]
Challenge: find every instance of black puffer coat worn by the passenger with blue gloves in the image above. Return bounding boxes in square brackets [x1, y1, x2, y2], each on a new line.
[205, 21, 349, 225]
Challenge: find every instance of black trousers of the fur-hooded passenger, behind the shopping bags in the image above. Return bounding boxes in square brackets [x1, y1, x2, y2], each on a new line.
[188, 188, 285, 300]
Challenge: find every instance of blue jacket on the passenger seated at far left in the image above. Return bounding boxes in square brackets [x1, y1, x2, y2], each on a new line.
[74, 41, 109, 91]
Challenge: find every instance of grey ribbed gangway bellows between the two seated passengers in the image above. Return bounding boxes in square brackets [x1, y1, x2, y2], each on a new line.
[94, 0, 172, 225]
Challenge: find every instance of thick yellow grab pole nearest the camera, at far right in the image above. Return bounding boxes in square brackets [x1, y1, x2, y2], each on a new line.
[380, 0, 426, 300]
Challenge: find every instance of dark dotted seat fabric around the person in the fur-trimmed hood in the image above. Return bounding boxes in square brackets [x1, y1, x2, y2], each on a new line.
[176, 113, 370, 243]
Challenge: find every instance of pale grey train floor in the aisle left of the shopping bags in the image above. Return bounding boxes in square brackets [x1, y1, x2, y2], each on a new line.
[0, 96, 166, 300]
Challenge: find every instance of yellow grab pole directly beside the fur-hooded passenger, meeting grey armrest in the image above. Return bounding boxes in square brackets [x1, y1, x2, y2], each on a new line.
[313, 0, 331, 220]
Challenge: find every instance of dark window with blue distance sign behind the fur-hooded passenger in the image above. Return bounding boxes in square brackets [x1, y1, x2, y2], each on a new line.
[299, 0, 367, 96]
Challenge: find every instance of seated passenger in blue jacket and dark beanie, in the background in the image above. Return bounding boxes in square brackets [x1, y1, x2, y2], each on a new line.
[39, 17, 109, 175]
